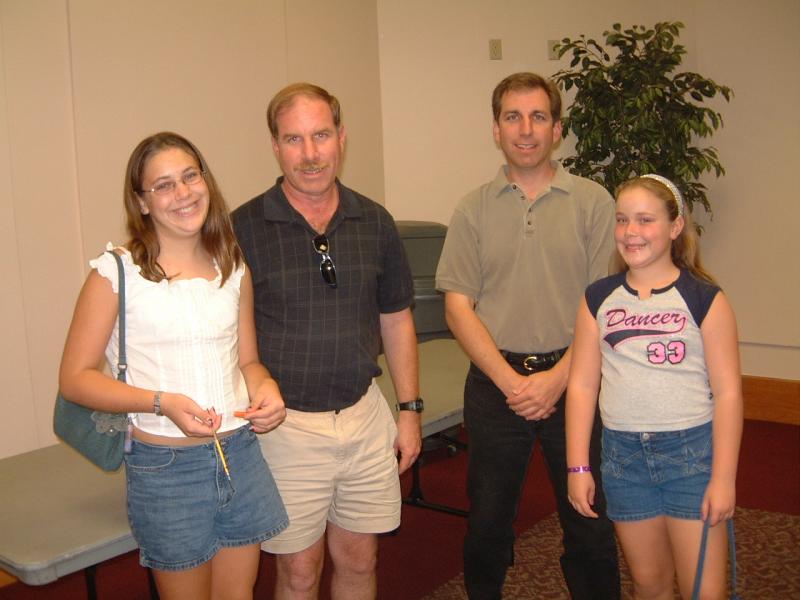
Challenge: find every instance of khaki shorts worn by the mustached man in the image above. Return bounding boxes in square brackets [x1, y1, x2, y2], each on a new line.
[260, 380, 400, 554]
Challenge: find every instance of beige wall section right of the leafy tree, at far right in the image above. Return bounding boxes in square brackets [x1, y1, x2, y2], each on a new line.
[697, 0, 800, 379]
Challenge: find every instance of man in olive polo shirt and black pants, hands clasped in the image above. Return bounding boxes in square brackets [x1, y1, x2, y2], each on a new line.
[436, 73, 619, 600]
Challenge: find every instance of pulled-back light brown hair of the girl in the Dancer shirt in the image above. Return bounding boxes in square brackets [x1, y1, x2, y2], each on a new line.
[612, 177, 717, 285]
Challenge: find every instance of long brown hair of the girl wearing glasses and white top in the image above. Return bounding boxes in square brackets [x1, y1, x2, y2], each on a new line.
[123, 131, 243, 287]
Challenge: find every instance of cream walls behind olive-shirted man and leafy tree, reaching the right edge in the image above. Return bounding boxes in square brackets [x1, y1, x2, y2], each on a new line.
[378, 0, 800, 379]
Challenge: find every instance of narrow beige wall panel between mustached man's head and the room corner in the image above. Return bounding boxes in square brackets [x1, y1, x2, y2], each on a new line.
[282, 0, 384, 203]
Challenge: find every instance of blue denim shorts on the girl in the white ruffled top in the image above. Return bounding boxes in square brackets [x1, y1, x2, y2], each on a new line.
[125, 425, 289, 571]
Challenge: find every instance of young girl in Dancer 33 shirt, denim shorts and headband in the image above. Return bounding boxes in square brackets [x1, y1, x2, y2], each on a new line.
[566, 175, 742, 600]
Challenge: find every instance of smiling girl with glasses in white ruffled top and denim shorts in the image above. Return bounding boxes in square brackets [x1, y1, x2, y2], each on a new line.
[59, 132, 288, 600]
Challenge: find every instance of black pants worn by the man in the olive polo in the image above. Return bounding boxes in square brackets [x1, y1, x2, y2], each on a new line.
[464, 365, 620, 600]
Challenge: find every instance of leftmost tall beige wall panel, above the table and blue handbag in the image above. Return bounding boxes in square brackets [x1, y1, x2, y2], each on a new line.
[0, 0, 82, 456]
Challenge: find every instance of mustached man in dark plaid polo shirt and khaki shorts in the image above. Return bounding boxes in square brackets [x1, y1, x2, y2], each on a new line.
[233, 83, 422, 600]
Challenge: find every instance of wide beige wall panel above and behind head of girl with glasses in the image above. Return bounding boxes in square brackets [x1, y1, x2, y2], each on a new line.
[70, 0, 285, 248]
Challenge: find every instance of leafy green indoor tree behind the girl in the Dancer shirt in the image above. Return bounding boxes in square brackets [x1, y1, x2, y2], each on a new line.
[553, 22, 733, 218]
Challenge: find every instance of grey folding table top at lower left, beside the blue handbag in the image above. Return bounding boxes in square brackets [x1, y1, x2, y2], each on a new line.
[0, 444, 137, 585]
